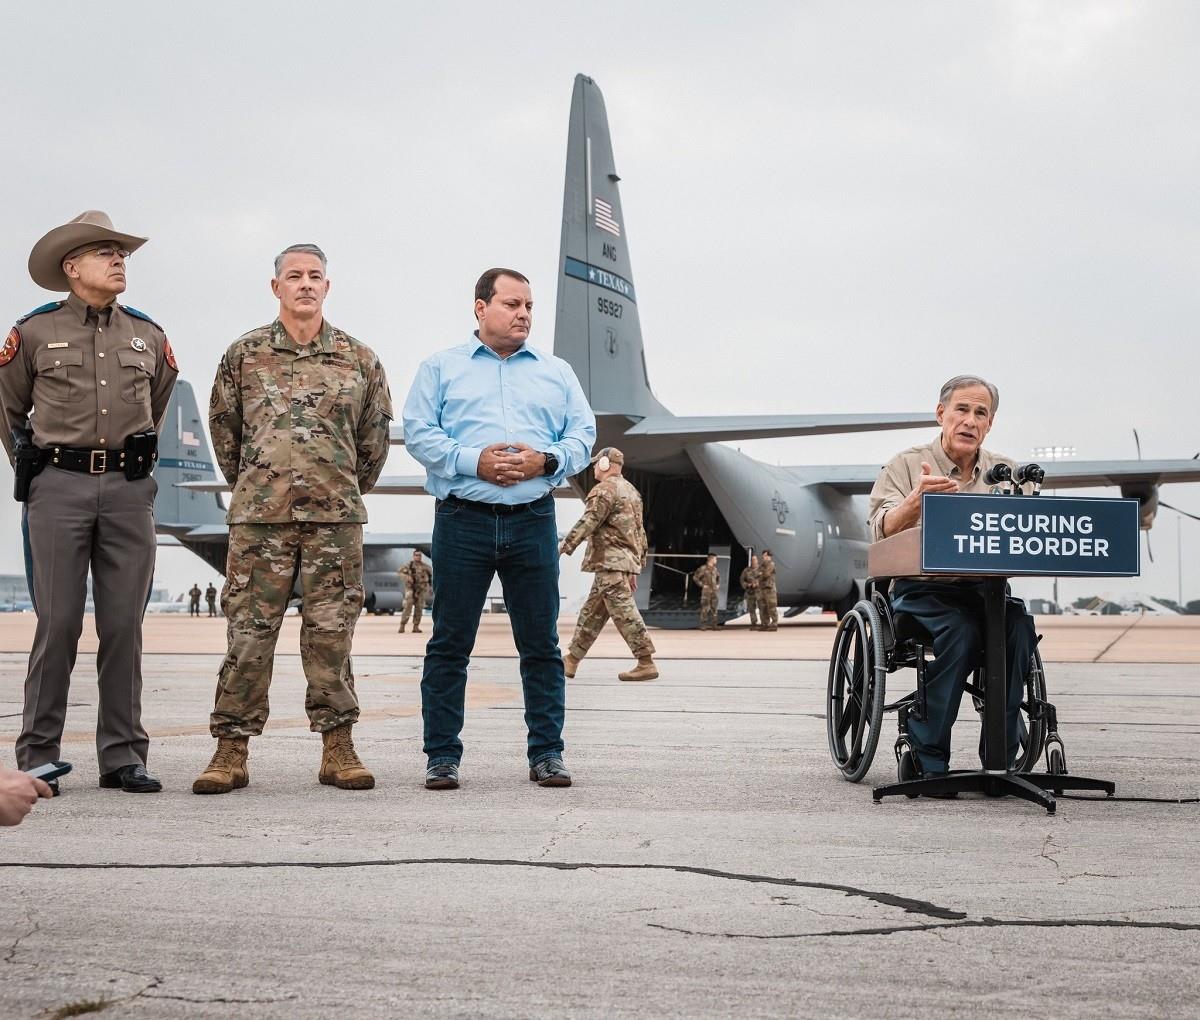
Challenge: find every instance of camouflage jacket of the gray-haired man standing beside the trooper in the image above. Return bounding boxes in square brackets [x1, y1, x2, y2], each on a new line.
[209, 319, 392, 524]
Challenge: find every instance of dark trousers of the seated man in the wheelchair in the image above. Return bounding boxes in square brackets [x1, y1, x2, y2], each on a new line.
[892, 581, 1037, 774]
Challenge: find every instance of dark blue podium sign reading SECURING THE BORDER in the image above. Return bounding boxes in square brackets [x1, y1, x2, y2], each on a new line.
[920, 492, 1141, 577]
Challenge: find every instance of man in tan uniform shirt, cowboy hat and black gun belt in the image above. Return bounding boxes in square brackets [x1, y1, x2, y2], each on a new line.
[0, 210, 178, 793]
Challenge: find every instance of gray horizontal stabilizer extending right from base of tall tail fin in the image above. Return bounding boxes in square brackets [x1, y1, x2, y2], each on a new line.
[625, 412, 937, 443]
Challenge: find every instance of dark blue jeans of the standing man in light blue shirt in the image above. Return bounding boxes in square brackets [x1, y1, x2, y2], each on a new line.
[421, 496, 566, 766]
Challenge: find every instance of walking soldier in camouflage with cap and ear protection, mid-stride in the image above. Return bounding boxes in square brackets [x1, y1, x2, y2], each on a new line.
[558, 446, 659, 680]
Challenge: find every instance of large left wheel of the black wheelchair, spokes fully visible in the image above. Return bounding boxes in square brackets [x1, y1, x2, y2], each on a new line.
[826, 600, 887, 782]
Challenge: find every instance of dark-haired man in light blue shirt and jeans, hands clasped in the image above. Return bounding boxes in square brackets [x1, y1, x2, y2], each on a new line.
[404, 269, 596, 790]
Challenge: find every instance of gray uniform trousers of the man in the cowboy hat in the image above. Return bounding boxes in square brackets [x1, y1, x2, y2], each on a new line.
[17, 467, 158, 773]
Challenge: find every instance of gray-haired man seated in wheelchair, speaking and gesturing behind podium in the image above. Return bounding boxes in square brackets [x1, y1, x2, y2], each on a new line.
[869, 376, 1037, 780]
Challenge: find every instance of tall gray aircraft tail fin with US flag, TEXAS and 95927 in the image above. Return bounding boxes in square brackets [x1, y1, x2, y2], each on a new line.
[554, 74, 666, 418]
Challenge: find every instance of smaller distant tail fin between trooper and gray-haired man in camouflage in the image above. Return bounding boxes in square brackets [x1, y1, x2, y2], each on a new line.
[154, 379, 226, 530]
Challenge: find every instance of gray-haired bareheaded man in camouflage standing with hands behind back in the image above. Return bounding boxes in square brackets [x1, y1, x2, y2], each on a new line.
[192, 245, 392, 793]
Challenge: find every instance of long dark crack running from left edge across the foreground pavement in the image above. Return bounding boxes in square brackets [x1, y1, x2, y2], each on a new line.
[0, 857, 966, 920]
